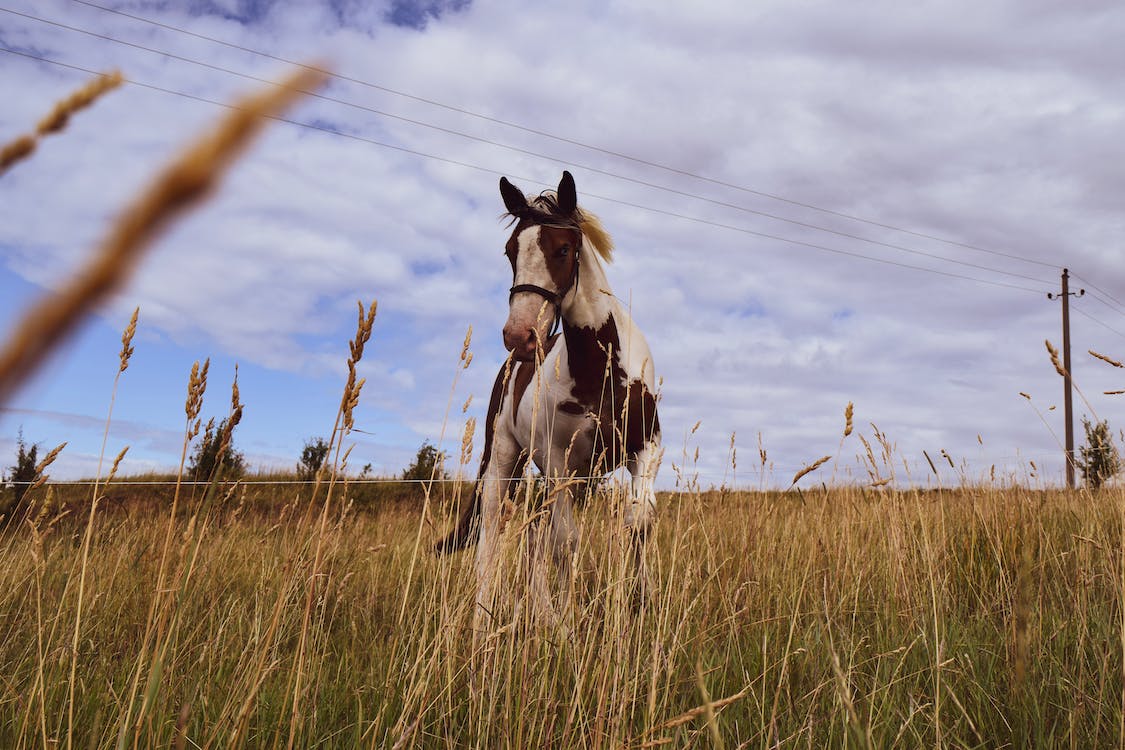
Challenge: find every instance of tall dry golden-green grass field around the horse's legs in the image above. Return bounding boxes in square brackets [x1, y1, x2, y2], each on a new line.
[0, 485, 1125, 748]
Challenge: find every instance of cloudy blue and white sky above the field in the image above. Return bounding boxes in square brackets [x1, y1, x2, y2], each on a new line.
[0, 0, 1125, 488]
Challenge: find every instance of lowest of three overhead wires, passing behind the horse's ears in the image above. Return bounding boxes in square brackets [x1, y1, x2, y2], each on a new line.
[0, 46, 1044, 295]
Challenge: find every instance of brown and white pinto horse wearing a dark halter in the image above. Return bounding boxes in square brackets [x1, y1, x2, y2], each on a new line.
[435, 171, 663, 622]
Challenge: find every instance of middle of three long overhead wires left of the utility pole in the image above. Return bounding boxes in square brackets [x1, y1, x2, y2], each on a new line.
[0, 0, 1045, 292]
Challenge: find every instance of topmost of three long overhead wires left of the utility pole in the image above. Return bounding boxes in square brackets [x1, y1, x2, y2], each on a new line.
[57, 0, 1055, 269]
